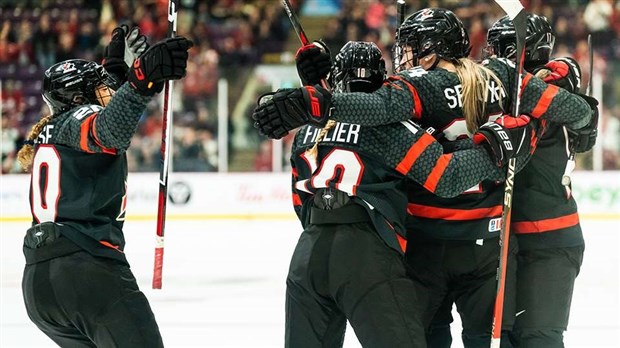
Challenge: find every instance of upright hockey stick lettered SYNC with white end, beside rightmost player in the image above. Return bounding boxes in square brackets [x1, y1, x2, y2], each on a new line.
[491, 0, 527, 348]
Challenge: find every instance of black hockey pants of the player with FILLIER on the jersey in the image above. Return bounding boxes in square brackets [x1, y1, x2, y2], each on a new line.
[285, 207, 426, 348]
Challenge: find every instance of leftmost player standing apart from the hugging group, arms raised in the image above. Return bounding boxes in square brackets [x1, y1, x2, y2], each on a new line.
[18, 33, 192, 347]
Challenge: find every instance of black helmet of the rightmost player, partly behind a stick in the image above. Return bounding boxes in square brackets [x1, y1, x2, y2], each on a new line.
[486, 13, 555, 70]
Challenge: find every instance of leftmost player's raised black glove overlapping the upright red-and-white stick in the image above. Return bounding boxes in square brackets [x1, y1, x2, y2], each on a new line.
[127, 36, 194, 96]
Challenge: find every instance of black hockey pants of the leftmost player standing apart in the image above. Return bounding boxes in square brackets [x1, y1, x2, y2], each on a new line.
[22, 224, 163, 348]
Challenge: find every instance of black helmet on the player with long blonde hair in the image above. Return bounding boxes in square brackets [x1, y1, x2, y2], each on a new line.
[394, 8, 471, 70]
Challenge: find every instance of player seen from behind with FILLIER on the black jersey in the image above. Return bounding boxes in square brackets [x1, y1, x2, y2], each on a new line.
[278, 42, 532, 347]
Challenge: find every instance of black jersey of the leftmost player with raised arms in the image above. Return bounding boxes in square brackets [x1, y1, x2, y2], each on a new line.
[30, 84, 151, 262]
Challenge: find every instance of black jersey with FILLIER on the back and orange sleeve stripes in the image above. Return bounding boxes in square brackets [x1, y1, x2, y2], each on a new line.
[291, 121, 528, 252]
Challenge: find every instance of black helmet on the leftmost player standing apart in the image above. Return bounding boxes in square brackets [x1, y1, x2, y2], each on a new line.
[43, 59, 117, 114]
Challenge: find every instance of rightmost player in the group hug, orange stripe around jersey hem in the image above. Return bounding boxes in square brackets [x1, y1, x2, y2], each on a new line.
[487, 14, 598, 348]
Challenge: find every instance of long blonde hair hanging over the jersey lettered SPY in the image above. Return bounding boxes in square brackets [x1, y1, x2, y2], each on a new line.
[454, 58, 504, 134]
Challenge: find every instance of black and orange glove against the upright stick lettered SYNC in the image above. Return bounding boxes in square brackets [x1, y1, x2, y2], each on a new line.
[474, 115, 535, 167]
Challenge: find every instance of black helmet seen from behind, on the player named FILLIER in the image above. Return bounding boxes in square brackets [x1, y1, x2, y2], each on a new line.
[331, 41, 387, 93]
